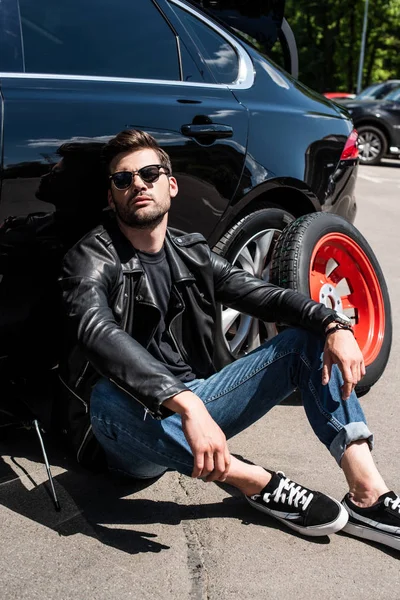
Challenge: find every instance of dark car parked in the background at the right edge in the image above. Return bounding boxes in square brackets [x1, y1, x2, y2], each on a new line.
[346, 82, 400, 165]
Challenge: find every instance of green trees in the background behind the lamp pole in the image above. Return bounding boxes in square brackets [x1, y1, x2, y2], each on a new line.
[285, 0, 400, 92]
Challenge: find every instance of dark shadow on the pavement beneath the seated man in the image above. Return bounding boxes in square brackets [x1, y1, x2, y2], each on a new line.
[4, 431, 400, 558]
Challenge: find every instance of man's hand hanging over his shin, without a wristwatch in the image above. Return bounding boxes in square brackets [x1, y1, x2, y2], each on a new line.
[164, 390, 231, 481]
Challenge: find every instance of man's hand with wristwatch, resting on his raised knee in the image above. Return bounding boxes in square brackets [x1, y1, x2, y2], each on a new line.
[322, 329, 365, 400]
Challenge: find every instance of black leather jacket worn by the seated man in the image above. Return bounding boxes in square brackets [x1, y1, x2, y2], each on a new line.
[60, 221, 332, 418]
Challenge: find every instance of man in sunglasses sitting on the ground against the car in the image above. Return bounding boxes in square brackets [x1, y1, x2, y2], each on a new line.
[61, 130, 400, 549]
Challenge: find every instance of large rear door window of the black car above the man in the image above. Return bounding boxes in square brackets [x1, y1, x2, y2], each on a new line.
[19, 0, 180, 80]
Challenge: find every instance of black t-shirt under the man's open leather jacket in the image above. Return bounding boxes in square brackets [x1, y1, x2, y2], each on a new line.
[137, 248, 196, 382]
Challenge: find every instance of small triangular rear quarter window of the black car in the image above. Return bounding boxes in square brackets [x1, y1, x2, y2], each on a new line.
[174, 5, 239, 83]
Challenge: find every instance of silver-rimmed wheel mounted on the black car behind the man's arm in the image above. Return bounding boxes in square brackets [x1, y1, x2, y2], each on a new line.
[214, 204, 294, 358]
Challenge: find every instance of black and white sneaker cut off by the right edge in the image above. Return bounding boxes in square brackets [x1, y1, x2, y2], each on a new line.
[342, 492, 400, 550]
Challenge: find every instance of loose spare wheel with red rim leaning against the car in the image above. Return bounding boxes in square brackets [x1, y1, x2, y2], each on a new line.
[271, 213, 392, 395]
